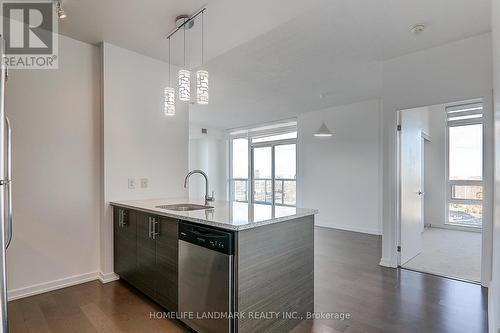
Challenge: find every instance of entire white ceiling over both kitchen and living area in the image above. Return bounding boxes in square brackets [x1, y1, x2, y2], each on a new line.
[60, 0, 491, 128]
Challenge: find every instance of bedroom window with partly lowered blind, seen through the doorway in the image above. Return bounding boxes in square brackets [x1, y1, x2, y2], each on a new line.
[446, 102, 483, 227]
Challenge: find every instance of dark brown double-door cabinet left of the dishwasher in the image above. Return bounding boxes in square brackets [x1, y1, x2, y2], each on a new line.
[114, 208, 178, 311]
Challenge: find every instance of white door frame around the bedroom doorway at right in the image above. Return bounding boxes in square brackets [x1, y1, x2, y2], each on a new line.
[396, 95, 494, 287]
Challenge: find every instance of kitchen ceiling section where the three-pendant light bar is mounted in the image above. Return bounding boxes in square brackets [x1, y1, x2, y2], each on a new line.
[59, 0, 321, 66]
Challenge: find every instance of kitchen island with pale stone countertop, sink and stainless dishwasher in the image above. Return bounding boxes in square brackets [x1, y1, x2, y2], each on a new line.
[111, 198, 317, 332]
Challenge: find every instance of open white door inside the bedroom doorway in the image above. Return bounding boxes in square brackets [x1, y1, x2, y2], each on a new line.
[400, 109, 423, 265]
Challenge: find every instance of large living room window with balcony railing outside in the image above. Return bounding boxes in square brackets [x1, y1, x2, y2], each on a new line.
[229, 122, 297, 206]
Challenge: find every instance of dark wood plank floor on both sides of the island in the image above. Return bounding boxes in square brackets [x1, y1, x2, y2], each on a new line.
[5, 228, 487, 333]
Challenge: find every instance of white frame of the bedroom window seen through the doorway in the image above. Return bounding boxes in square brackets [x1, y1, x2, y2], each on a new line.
[445, 99, 485, 229]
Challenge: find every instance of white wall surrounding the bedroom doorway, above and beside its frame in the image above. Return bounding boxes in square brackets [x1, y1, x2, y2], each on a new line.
[381, 33, 492, 267]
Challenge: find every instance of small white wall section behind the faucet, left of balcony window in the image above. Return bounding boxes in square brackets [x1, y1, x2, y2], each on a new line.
[189, 124, 227, 200]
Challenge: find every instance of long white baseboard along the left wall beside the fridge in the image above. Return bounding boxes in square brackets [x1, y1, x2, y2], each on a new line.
[7, 272, 99, 301]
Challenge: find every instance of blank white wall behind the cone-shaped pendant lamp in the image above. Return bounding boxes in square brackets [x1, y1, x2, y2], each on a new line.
[298, 100, 382, 234]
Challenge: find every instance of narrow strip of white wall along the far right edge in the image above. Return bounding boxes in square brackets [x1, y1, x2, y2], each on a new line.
[488, 0, 500, 333]
